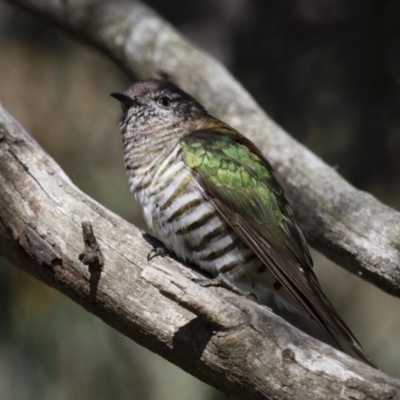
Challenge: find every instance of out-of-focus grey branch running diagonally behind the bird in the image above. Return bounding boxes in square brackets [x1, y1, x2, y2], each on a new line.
[8, 0, 400, 296]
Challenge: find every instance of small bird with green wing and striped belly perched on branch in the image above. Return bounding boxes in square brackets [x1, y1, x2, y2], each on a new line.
[111, 78, 377, 368]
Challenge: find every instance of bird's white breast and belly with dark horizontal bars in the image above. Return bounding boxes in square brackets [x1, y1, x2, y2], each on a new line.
[129, 145, 293, 310]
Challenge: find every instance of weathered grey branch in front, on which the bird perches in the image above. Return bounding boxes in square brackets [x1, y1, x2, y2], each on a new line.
[0, 106, 400, 400]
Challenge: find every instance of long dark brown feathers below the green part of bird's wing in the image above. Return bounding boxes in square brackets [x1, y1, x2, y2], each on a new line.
[213, 197, 378, 369]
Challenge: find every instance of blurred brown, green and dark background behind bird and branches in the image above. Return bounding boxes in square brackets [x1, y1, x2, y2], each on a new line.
[0, 0, 400, 400]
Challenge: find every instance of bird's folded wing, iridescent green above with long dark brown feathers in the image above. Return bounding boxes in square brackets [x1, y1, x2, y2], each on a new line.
[180, 126, 375, 367]
